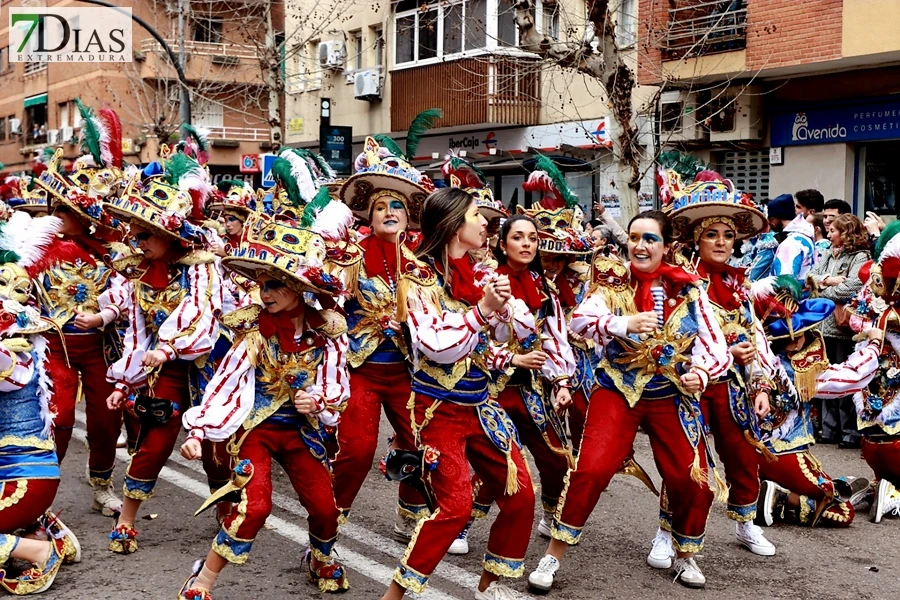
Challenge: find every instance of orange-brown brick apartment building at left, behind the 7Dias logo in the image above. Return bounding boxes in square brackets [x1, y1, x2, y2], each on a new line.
[0, 0, 283, 185]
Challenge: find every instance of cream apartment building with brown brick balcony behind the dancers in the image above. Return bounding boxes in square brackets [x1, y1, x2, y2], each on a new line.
[285, 0, 653, 216]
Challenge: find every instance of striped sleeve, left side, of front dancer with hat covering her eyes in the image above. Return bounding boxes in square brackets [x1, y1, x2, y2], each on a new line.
[181, 340, 256, 442]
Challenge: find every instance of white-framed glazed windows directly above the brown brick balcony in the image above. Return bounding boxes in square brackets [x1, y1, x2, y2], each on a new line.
[394, 0, 492, 64]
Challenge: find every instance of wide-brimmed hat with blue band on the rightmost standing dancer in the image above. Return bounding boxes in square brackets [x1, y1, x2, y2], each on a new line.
[660, 162, 769, 243]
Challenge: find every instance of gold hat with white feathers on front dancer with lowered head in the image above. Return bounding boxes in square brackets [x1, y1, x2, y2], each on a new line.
[222, 187, 362, 296]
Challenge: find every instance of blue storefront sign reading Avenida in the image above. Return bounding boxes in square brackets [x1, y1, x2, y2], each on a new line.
[772, 99, 900, 146]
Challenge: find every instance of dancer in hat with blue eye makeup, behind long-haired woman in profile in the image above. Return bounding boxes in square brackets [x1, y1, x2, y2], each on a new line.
[332, 138, 434, 528]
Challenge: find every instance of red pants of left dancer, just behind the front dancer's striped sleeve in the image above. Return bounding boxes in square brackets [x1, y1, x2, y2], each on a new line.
[124, 360, 231, 500]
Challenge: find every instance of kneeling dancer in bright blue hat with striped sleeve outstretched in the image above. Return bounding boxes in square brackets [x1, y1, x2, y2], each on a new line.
[753, 275, 884, 527]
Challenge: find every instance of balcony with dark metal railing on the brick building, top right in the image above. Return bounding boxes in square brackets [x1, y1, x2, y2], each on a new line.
[660, 0, 747, 60]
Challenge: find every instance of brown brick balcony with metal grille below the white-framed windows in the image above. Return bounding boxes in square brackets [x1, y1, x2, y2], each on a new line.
[391, 57, 541, 131]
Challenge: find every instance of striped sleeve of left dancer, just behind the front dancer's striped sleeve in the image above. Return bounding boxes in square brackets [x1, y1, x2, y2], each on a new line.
[157, 262, 222, 360]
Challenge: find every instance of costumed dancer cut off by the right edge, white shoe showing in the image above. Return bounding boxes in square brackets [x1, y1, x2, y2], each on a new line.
[851, 221, 900, 523]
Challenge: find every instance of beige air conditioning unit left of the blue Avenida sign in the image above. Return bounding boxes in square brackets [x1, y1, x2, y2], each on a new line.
[708, 86, 765, 142]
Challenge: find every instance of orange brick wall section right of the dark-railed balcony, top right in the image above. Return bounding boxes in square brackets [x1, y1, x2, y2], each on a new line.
[747, 0, 843, 70]
